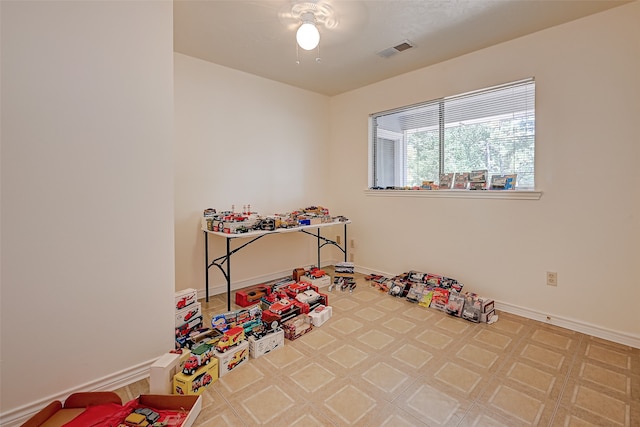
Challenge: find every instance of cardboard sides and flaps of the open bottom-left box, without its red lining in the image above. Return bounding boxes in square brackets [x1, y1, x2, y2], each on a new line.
[22, 391, 202, 427]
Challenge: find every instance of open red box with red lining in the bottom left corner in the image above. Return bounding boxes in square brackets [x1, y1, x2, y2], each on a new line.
[22, 391, 202, 427]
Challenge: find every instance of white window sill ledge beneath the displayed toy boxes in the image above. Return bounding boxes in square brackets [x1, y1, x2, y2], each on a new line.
[364, 190, 542, 200]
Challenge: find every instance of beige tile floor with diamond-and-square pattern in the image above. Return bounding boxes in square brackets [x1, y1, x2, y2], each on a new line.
[112, 275, 640, 427]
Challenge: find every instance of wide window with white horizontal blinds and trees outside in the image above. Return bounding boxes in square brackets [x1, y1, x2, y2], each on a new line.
[370, 79, 535, 190]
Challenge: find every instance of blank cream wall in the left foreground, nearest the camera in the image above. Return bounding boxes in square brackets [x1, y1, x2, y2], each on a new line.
[0, 1, 174, 425]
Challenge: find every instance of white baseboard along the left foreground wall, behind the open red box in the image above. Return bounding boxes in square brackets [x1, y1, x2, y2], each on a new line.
[0, 359, 155, 427]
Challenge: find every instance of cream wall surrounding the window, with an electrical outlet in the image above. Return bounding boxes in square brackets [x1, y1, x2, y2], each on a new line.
[330, 2, 640, 345]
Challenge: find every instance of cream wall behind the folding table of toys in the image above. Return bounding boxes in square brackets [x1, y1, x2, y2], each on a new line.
[175, 54, 338, 295]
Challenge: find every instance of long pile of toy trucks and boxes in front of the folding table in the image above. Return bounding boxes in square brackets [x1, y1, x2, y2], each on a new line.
[155, 267, 332, 395]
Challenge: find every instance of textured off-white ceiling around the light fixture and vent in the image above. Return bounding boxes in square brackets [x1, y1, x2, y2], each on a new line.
[174, 0, 629, 95]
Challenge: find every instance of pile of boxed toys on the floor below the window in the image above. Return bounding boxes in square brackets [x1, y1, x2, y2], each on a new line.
[365, 270, 497, 323]
